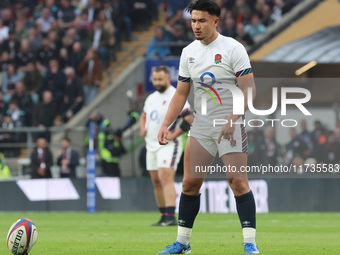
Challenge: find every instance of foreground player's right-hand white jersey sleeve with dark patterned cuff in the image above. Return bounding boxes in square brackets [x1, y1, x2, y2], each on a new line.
[231, 44, 253, 77]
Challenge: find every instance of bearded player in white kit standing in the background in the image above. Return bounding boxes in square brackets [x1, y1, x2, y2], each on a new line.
[140, 66, 190, 226]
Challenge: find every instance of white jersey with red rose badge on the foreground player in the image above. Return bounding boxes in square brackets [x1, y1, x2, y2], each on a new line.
[178, 34, 252, 127]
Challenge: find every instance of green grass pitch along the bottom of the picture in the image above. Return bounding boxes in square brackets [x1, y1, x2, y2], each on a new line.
[0, 212, 340, 255]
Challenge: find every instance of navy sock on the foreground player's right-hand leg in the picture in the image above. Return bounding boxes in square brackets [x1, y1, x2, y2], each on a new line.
[235, 191, 256, 228]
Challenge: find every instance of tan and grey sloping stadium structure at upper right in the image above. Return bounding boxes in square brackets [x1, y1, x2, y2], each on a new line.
[250, 0, 340, 65]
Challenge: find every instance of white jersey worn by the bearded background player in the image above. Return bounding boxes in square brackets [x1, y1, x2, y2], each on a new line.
[143, 86, 190, 151]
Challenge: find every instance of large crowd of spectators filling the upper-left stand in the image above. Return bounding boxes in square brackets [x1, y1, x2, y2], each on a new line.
[0, 0, 157, 154]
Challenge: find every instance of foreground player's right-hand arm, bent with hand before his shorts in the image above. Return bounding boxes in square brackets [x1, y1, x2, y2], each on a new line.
[217, 73, 256, 143]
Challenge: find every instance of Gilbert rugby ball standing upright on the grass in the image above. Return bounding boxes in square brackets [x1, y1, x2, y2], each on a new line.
[7, 219, 38, 255]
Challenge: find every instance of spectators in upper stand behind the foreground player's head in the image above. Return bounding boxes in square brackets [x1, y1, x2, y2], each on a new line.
[147, 0, 301, 57]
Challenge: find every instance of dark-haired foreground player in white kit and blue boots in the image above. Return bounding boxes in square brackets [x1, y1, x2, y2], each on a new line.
[157, 0, 259, 254]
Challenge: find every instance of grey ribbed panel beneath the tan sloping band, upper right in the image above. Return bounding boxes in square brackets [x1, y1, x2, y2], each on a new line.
[263, 26, 340, 63]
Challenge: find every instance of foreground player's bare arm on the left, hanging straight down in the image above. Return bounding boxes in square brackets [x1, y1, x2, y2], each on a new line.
[158, 80, 190, 145]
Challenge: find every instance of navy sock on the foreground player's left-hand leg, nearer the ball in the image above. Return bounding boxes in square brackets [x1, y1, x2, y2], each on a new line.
[178, 193, 201, 228]
